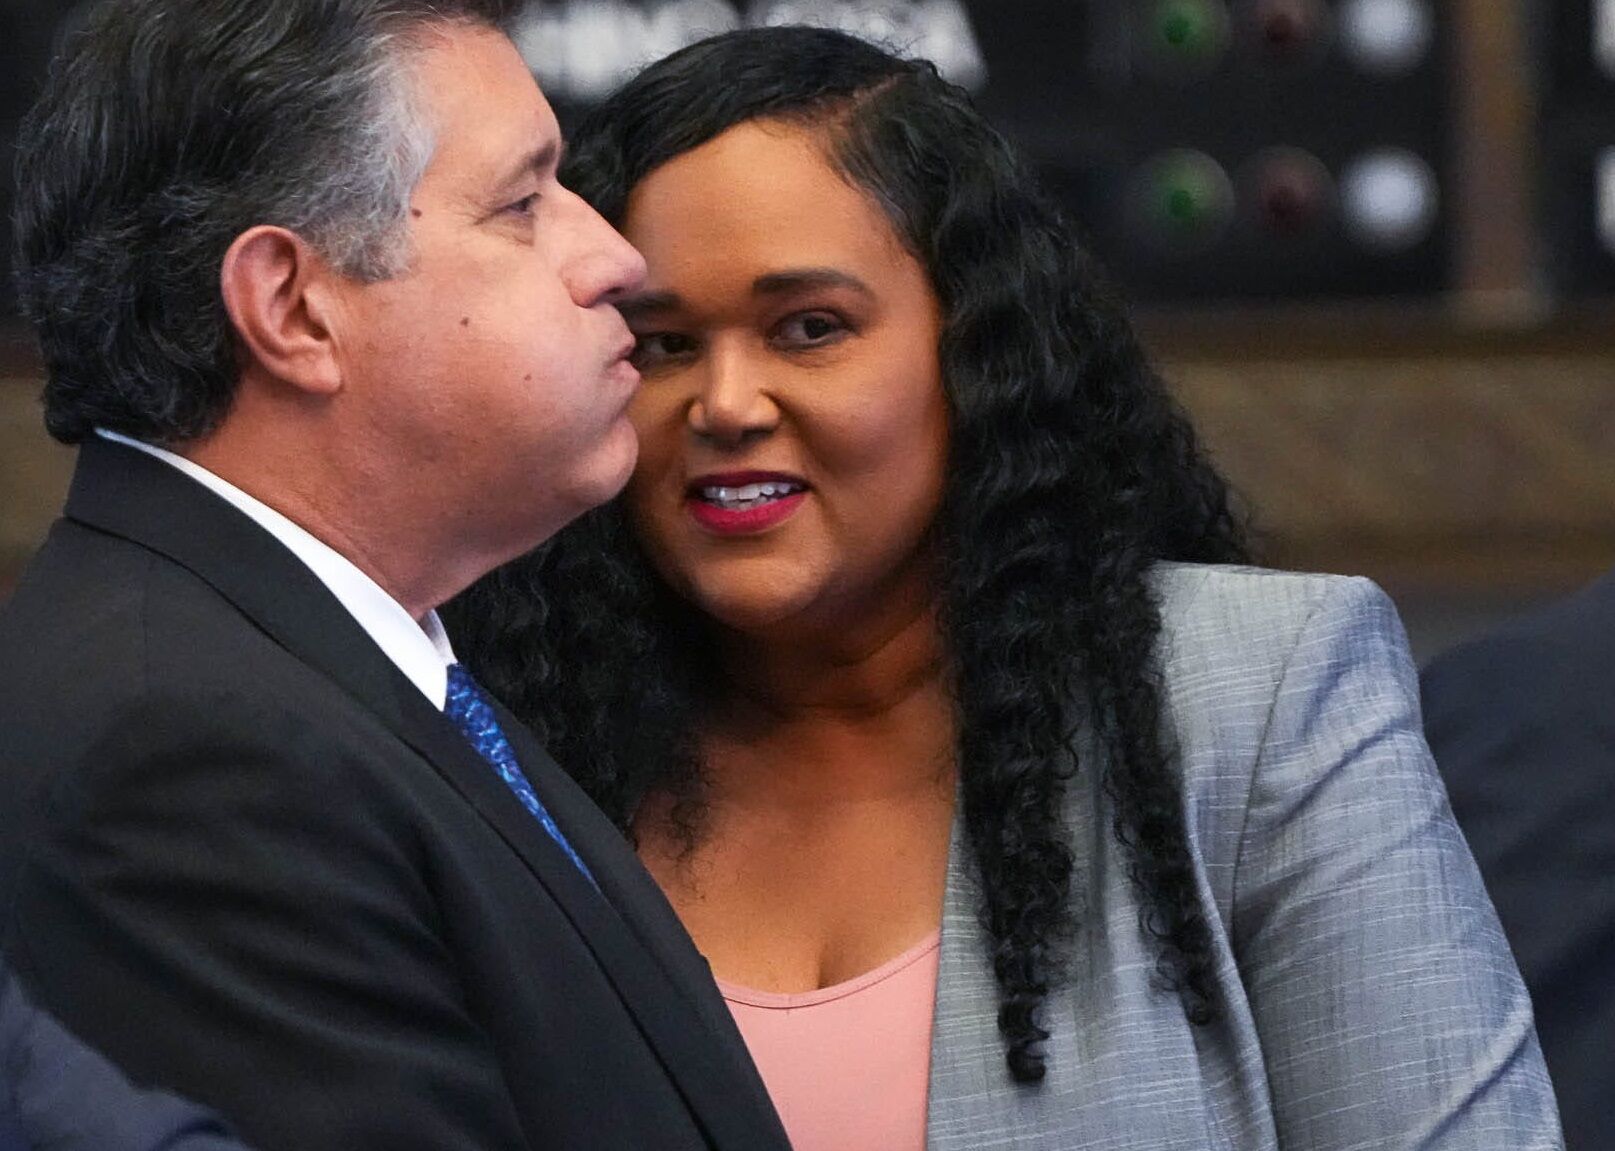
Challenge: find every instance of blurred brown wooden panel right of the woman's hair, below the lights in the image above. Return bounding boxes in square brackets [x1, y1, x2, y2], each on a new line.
[1168, 355, 1615, 592]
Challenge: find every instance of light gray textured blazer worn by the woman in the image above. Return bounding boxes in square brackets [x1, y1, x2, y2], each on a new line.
[927, 565, 1563, 1151]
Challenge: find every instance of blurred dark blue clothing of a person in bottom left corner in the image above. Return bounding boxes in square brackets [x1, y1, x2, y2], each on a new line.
[0, 962, 245, 1151]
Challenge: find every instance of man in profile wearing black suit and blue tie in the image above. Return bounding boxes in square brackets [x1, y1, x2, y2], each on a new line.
[0, 0, 785, 1151]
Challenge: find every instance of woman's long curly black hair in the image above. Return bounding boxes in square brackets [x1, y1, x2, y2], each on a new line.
[449, 27, 1247, 1082]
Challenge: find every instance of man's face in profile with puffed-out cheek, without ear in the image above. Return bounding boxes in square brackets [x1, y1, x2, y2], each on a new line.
[336, 27, 644, 567]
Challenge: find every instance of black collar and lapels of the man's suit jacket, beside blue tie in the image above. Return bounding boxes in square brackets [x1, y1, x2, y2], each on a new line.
[66, 441, 785, 1151]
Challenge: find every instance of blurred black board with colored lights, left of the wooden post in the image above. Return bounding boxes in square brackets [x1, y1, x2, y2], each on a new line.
[0, 0, 1463, 315]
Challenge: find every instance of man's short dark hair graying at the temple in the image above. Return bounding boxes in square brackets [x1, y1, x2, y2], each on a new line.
[15, 0, 520, 444]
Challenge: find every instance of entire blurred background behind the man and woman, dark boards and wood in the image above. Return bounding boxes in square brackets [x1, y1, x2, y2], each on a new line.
[0, 0, 1615, 659]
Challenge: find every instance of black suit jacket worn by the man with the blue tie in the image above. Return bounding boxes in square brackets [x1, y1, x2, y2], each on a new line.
[0, 441, 787, 1151]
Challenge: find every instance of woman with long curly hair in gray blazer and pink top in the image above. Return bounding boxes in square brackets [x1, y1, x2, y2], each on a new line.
[457, 29, 1557, 1149]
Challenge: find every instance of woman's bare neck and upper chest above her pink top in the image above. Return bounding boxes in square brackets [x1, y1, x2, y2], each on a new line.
[638, 594, 954, 991]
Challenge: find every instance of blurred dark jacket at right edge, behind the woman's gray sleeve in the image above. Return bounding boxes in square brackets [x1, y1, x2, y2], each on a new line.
[1423, 573, 1615, 1151]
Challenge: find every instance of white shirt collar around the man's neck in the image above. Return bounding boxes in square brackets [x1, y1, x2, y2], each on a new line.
[95, 428, 455, 712]
